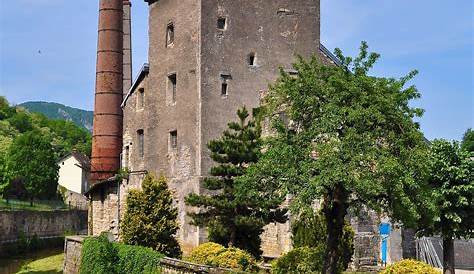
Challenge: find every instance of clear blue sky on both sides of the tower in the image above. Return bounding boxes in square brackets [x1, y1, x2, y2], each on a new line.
[0, 0, 474, 139]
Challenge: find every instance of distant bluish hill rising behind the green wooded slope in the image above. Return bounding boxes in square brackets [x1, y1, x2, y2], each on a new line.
[19, 102, 94, 131]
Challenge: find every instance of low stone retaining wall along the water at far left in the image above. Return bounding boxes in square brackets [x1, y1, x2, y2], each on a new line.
[0, 210, 87, 244]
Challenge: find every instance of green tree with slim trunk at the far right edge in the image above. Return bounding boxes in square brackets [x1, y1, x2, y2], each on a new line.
[423, 140, 474, 274]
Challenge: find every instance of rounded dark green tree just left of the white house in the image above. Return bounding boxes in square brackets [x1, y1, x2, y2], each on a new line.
[6, 131, 59, 203]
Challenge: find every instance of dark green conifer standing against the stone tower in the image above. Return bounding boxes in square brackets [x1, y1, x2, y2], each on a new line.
[186, 107, 285, 257]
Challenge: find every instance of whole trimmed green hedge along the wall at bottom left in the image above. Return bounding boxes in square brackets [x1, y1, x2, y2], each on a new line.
[80, 235, 164, 274]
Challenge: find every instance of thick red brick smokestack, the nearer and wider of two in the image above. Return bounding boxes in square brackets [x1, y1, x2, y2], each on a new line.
[91, 0, 123, 183]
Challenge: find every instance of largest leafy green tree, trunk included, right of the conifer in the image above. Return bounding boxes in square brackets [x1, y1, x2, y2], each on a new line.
[245, 42, 431, 273]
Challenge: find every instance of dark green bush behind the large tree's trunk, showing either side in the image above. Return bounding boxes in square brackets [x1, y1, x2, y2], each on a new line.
[291, 209, 354, 273]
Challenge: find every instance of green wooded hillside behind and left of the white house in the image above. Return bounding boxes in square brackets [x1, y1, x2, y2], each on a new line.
[0, 96, 92, 199]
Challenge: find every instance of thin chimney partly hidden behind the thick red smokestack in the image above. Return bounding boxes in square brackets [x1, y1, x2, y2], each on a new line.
[123, 0, 132, 96]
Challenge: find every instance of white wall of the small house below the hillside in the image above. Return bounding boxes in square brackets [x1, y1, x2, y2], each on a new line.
[58, 155, 87, 194]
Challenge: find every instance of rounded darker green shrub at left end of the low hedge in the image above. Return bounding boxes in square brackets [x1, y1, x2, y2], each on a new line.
[80, 235, 118, 274]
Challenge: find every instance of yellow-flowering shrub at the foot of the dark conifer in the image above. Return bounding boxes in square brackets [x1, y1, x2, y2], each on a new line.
[186, 243, 257, 271]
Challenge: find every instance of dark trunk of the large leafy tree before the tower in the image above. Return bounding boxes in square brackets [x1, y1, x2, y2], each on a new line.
[322, 184, 348, 274]
